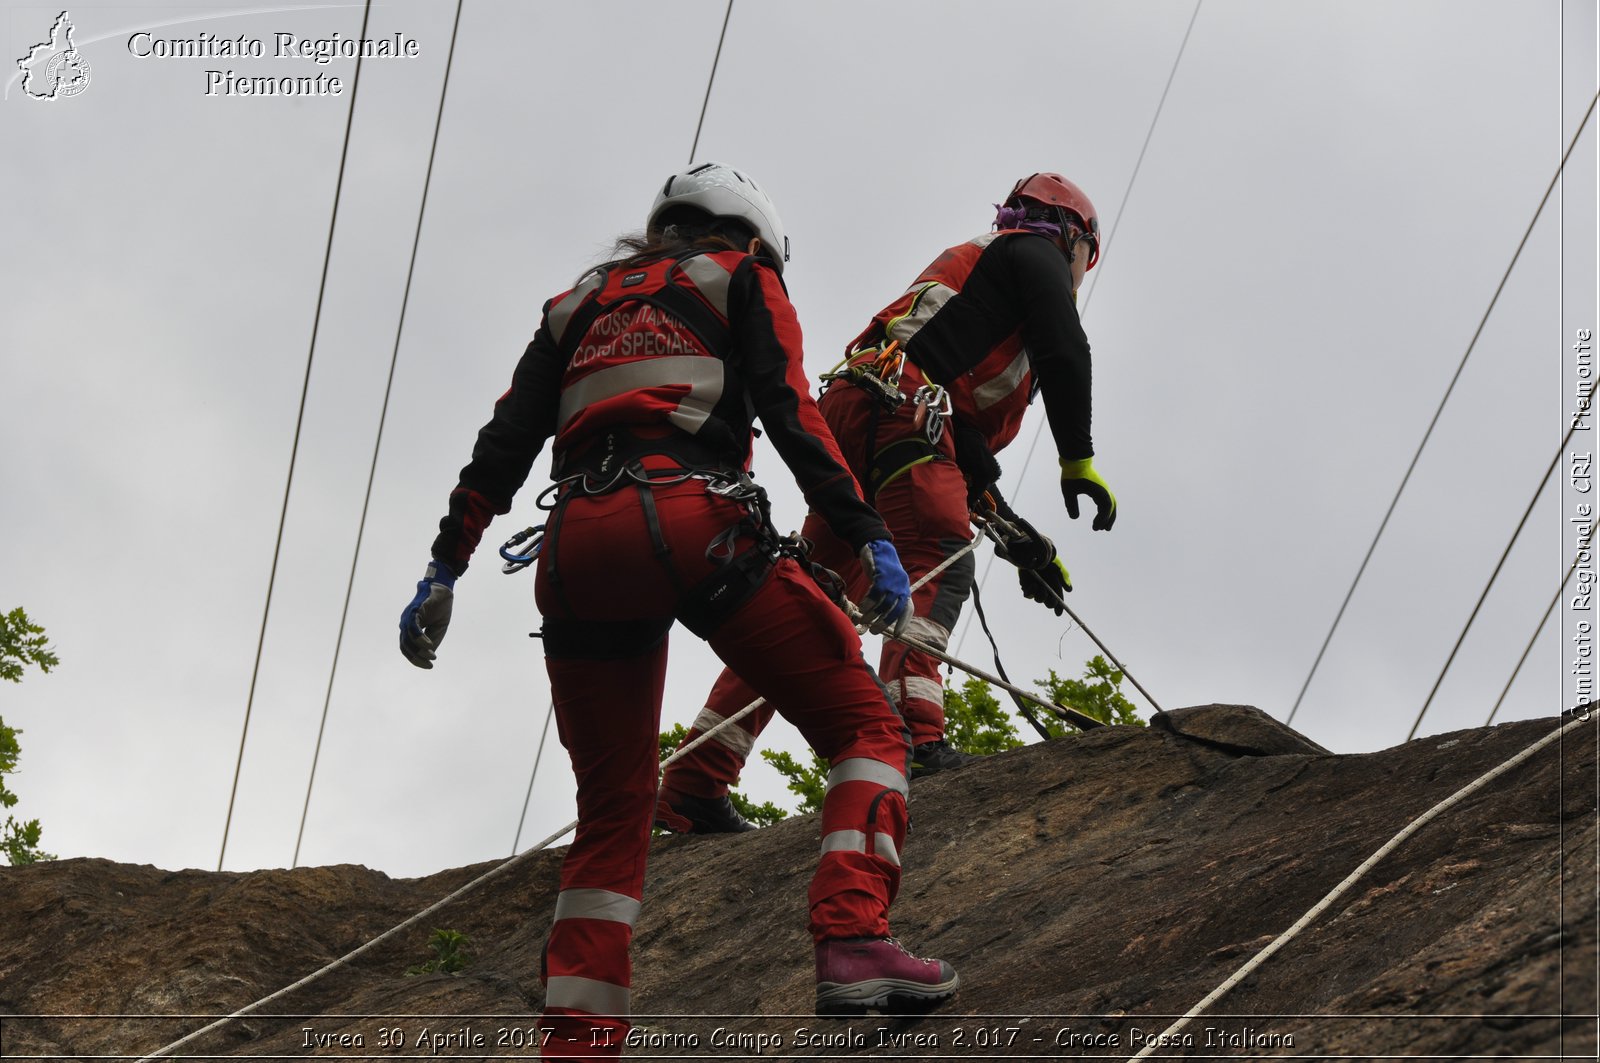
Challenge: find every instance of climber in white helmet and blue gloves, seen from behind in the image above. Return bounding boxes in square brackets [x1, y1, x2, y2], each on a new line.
[400, 163, 957, 1057]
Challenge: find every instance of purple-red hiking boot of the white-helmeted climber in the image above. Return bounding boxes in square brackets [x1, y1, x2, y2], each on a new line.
[816, 938, 960, 1018]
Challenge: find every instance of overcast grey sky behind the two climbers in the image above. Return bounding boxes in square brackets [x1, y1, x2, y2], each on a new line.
[0, 0, 1597, 876]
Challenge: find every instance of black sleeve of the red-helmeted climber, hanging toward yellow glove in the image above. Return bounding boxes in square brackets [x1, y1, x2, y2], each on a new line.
[1002, 235, 1094, 461]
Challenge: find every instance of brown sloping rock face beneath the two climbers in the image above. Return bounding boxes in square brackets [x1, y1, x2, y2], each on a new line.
[0, 706, 1600, 1060]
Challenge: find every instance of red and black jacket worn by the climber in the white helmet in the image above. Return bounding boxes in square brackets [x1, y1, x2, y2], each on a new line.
[434, 251, 890, 575]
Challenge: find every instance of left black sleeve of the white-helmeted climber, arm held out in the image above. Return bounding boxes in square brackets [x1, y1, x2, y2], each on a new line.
[434, 315, 565, 576]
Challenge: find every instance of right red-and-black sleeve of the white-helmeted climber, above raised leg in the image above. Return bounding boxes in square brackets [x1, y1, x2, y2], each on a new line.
[728, 258, 890, 551]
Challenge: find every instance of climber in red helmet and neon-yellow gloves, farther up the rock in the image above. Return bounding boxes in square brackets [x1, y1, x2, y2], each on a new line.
[658, 173, 1117, 832]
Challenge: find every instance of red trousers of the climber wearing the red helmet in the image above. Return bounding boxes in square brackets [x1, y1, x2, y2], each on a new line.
[662, 377, 976, 797]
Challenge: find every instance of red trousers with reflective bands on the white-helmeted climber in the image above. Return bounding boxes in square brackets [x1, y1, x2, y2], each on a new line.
[536, 480, 910, 1057]
